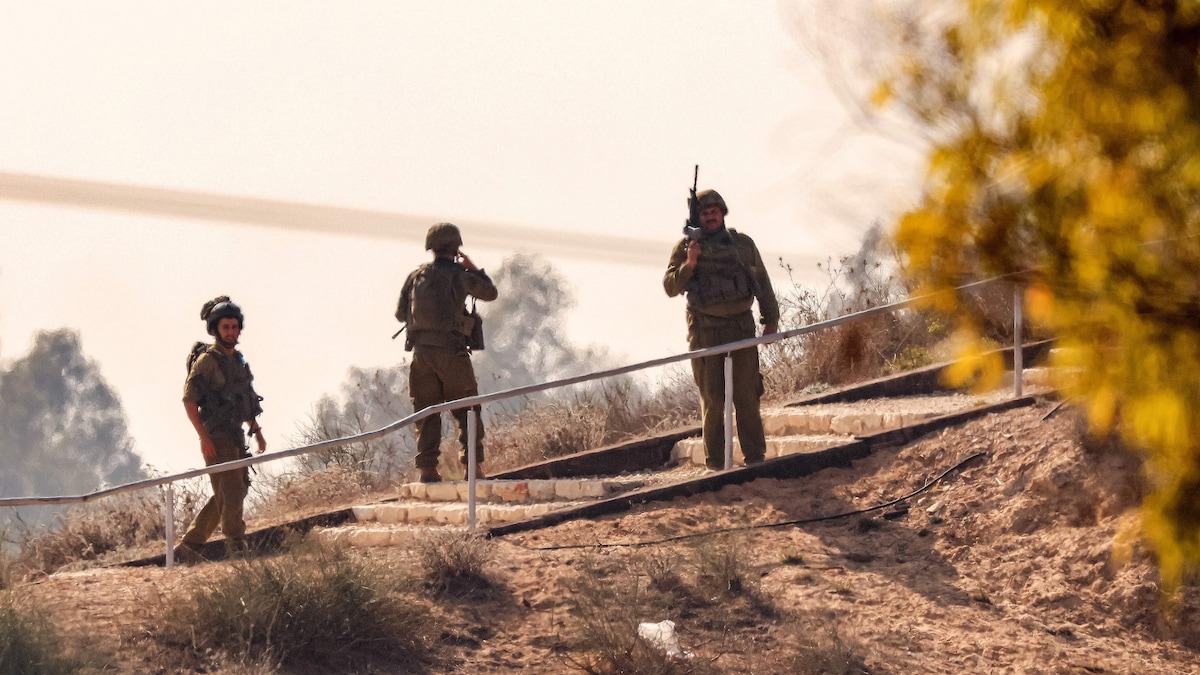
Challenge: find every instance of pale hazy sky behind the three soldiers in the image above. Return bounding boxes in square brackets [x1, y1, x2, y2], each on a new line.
[0, 0, 920, 471]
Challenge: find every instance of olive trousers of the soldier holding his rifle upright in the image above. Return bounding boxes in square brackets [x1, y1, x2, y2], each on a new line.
[688, 312, 767, 468]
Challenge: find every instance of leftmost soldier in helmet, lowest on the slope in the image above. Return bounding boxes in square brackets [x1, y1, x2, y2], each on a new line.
[175, 295, 266, 562]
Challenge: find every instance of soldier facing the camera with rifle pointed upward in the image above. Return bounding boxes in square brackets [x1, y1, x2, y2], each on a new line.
[662, 190, 779, 470]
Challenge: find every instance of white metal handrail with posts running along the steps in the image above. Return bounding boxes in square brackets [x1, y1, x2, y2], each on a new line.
[0, 273, 1024, 565]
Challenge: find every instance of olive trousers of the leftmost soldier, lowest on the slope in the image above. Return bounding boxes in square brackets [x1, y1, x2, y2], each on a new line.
[184, 429, 250, 550]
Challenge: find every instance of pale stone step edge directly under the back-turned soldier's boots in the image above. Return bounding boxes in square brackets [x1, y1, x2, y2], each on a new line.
[398, 478, 646, 502]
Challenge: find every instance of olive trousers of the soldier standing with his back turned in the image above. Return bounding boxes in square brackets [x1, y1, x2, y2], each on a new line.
[408, 345, 484, 468]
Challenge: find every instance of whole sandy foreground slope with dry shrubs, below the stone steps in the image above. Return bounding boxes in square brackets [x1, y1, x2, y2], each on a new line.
[11, 404, 1200, 675]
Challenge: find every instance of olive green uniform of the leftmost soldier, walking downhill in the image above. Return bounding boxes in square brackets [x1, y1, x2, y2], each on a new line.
[184, 346, 262, 550]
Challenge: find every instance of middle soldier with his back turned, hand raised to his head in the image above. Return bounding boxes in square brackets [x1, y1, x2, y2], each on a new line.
[396, 222, 498, 483]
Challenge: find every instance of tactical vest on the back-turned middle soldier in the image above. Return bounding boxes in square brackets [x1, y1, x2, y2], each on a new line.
[404, 261, 481, 348]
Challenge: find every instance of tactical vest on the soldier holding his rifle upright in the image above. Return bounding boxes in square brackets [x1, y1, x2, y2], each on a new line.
[684, 229, 754, 316]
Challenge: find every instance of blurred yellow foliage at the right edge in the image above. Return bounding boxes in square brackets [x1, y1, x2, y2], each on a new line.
[875, 0, 1200, 589]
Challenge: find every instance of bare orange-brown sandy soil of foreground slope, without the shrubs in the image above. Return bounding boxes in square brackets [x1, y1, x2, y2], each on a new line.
[18, 396, 1200, 675]
